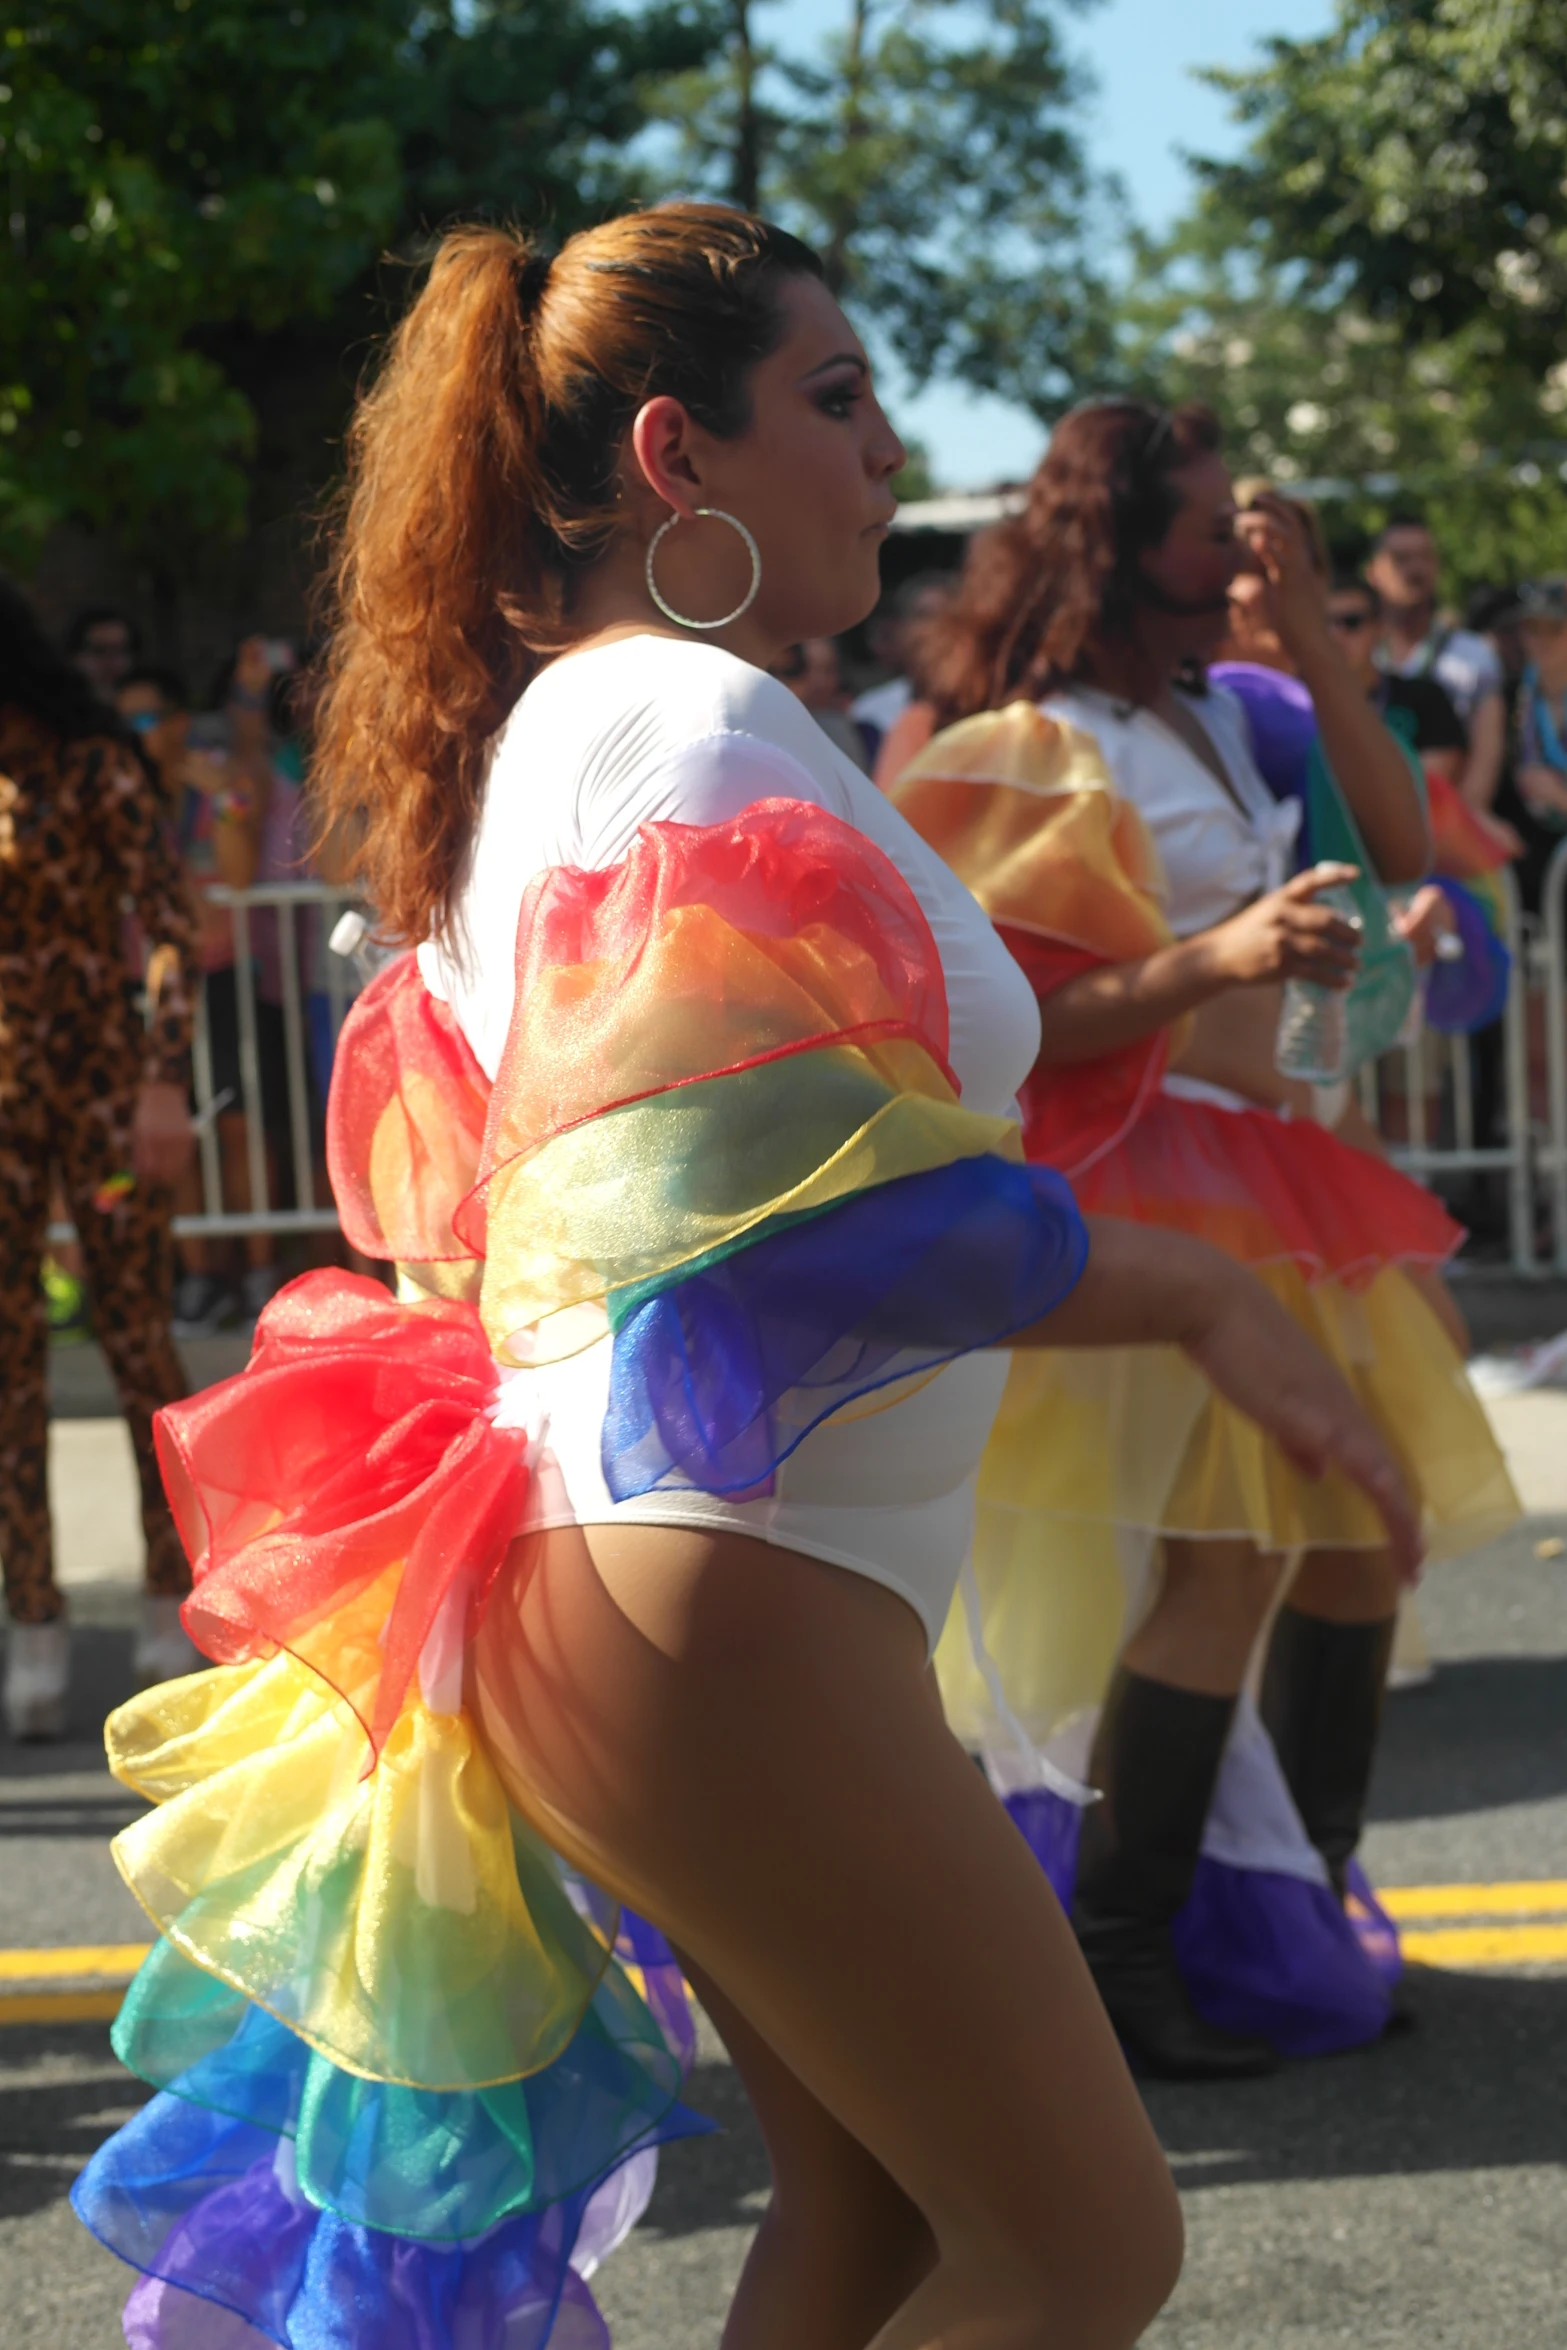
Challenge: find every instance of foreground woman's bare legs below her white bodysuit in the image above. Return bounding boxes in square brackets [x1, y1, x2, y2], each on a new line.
[475, 1528, 1179, 2350]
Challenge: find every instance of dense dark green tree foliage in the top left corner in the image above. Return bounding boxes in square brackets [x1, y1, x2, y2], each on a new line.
[0, 0, 712, 585]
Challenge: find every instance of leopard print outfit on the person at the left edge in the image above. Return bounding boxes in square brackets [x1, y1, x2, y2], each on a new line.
[0, 707, 195, 1624]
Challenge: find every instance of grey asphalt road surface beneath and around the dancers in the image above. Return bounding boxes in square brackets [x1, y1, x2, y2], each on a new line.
[0, 1485, 1567, 2350]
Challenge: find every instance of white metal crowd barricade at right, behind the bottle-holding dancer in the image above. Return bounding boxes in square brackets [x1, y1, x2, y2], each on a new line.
[1360, 858, 1541, 1274]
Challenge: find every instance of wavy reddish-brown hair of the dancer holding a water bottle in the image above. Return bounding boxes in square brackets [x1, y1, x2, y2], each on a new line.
[919, 400, 1219, 726]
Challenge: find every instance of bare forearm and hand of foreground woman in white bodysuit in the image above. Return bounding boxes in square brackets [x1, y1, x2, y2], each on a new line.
[1010, 1215, 1424, 1582]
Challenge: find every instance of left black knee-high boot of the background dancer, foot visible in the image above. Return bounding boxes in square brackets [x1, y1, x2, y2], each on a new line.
[1071, 1671, 1278, 2080]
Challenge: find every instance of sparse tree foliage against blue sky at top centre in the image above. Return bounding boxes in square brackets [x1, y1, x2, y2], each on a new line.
[667, 0, 1114, 418]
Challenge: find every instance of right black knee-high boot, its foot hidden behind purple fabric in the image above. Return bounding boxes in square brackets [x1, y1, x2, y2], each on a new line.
[1259, 1607, 1398, 1901]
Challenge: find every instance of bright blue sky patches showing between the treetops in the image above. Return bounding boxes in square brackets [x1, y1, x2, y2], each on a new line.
[784, 0, 1334, 489]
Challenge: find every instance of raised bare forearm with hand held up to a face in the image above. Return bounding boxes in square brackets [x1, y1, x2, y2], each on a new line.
[1238, 496, 1431, 886]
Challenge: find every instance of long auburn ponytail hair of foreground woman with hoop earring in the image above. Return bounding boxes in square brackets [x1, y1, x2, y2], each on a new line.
[315, 204, 820, 940]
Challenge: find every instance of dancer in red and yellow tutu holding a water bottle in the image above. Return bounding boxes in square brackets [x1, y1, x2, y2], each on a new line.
[893, 402, 1515, 2075]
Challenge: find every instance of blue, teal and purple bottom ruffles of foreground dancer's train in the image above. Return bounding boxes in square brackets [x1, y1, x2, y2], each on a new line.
[70, 1915, 712, 2350]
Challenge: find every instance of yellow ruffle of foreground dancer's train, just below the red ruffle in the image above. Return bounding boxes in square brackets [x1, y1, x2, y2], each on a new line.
[108, 1654, 618, 2089]
